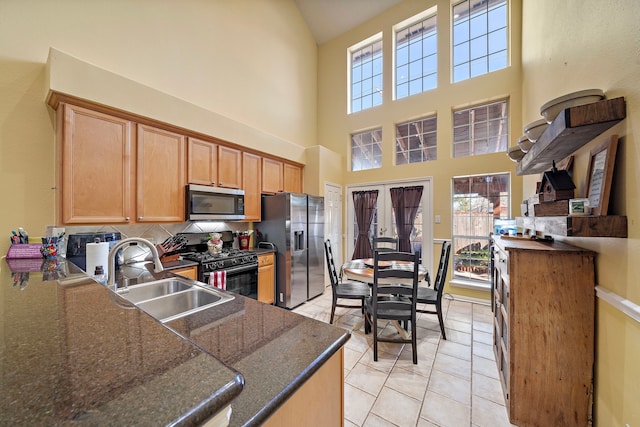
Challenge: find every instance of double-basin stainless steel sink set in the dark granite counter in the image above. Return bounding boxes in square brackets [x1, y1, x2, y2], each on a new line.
[118, 278, 234, 323]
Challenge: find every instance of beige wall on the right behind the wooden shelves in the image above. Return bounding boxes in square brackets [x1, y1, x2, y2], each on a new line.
[522, 0, 640, 427]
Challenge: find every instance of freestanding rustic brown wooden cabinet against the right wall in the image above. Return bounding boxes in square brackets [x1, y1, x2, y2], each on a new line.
[492, 237, 595, 427]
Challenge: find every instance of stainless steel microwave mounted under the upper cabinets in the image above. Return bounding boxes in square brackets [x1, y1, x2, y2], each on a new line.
[185, 184, 245, 221]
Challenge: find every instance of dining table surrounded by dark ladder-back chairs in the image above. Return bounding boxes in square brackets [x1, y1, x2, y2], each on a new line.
[340, 258, 430, 339]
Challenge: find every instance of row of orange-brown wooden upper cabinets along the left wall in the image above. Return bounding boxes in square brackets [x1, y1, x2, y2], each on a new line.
[57, 96, 303, 225]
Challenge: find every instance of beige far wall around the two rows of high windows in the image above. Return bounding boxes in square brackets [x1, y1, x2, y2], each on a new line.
[318, 0, 523, 299]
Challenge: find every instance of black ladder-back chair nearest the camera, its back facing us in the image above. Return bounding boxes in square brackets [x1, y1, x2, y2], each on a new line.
[364, 252, 420, 364]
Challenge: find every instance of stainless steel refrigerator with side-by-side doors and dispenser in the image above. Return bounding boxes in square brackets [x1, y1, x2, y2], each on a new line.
[256, 193, 324, 308]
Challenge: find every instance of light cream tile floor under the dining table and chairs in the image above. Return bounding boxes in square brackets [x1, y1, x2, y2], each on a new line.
[294, 288, 511, 427]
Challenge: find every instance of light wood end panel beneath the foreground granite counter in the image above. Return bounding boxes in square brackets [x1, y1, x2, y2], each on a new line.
[262, 348, 344, 427]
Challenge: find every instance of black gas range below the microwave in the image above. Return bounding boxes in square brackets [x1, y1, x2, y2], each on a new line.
[180, 232, 258, 299]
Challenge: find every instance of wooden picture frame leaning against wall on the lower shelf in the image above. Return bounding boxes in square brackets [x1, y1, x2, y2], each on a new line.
[587, 135, 618, 216]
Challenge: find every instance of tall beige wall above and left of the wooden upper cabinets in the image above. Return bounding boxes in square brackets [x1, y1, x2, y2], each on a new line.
[0, 0, 317, 254]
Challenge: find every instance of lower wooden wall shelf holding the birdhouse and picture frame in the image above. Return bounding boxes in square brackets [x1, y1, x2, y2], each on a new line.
[516, 215, 627, 238]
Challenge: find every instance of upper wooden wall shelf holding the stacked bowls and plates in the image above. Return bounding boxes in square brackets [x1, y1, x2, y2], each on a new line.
[516, 97, 626, 176]
